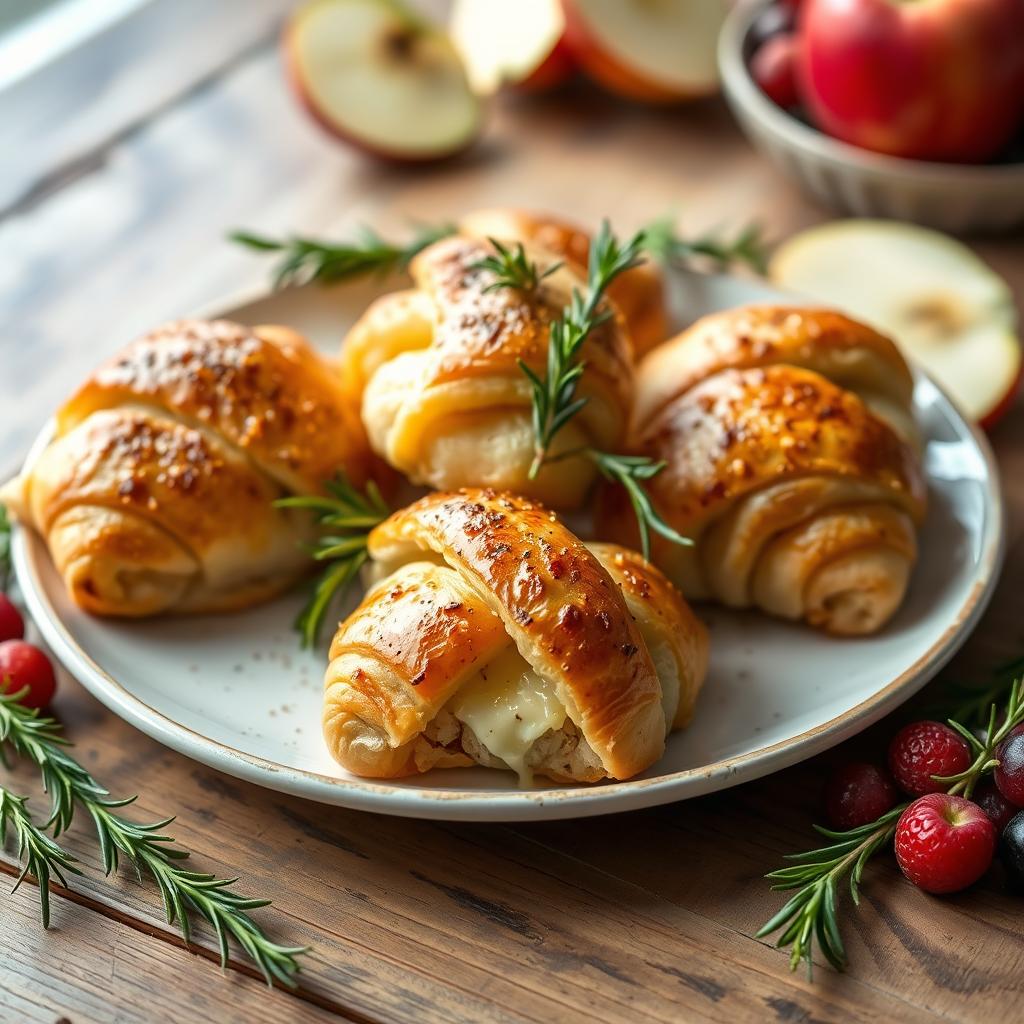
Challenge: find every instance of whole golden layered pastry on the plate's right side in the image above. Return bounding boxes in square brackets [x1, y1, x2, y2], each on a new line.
[598, 307, 926, 635]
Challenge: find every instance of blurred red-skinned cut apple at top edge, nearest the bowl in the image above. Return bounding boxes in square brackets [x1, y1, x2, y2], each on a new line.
[562, 0, 728, 103]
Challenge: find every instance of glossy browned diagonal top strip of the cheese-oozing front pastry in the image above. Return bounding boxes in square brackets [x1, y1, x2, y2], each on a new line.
[369, 489, 665, 778]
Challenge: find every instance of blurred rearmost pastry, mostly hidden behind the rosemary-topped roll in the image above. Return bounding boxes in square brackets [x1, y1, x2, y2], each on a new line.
[459, 207, 669, 356]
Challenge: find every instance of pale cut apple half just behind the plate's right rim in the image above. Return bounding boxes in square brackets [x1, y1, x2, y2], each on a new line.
[769, 220, 1022, 429]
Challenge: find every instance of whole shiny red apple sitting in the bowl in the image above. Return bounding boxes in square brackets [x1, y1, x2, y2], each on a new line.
[797, 0, 1024, 163]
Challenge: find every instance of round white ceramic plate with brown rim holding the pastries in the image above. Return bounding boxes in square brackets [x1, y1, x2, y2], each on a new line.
[13, 273, 1002, 821]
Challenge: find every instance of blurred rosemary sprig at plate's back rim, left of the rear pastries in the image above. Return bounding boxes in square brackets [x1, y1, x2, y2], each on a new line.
[234, 224, 456, 288]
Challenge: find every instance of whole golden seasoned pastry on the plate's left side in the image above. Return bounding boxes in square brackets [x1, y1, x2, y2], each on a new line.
[0, 321, 370, 616]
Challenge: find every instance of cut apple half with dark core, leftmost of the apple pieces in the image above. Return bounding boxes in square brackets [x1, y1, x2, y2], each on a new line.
[284, 0, 481, 161]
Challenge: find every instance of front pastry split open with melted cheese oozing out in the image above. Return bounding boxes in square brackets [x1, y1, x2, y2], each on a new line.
[324, 489, 708, 782]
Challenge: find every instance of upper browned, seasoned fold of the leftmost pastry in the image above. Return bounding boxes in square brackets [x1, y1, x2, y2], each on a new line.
[57, 321, 368, 490]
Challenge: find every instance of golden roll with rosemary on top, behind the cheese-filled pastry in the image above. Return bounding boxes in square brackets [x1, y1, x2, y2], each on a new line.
[342, 237, 633, 508]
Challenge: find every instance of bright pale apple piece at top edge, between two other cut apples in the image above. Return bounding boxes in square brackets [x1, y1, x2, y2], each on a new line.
[449, 0, 574, 95]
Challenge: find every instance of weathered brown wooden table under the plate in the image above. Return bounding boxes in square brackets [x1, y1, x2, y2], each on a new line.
[6, 8, 1024, 1024]
